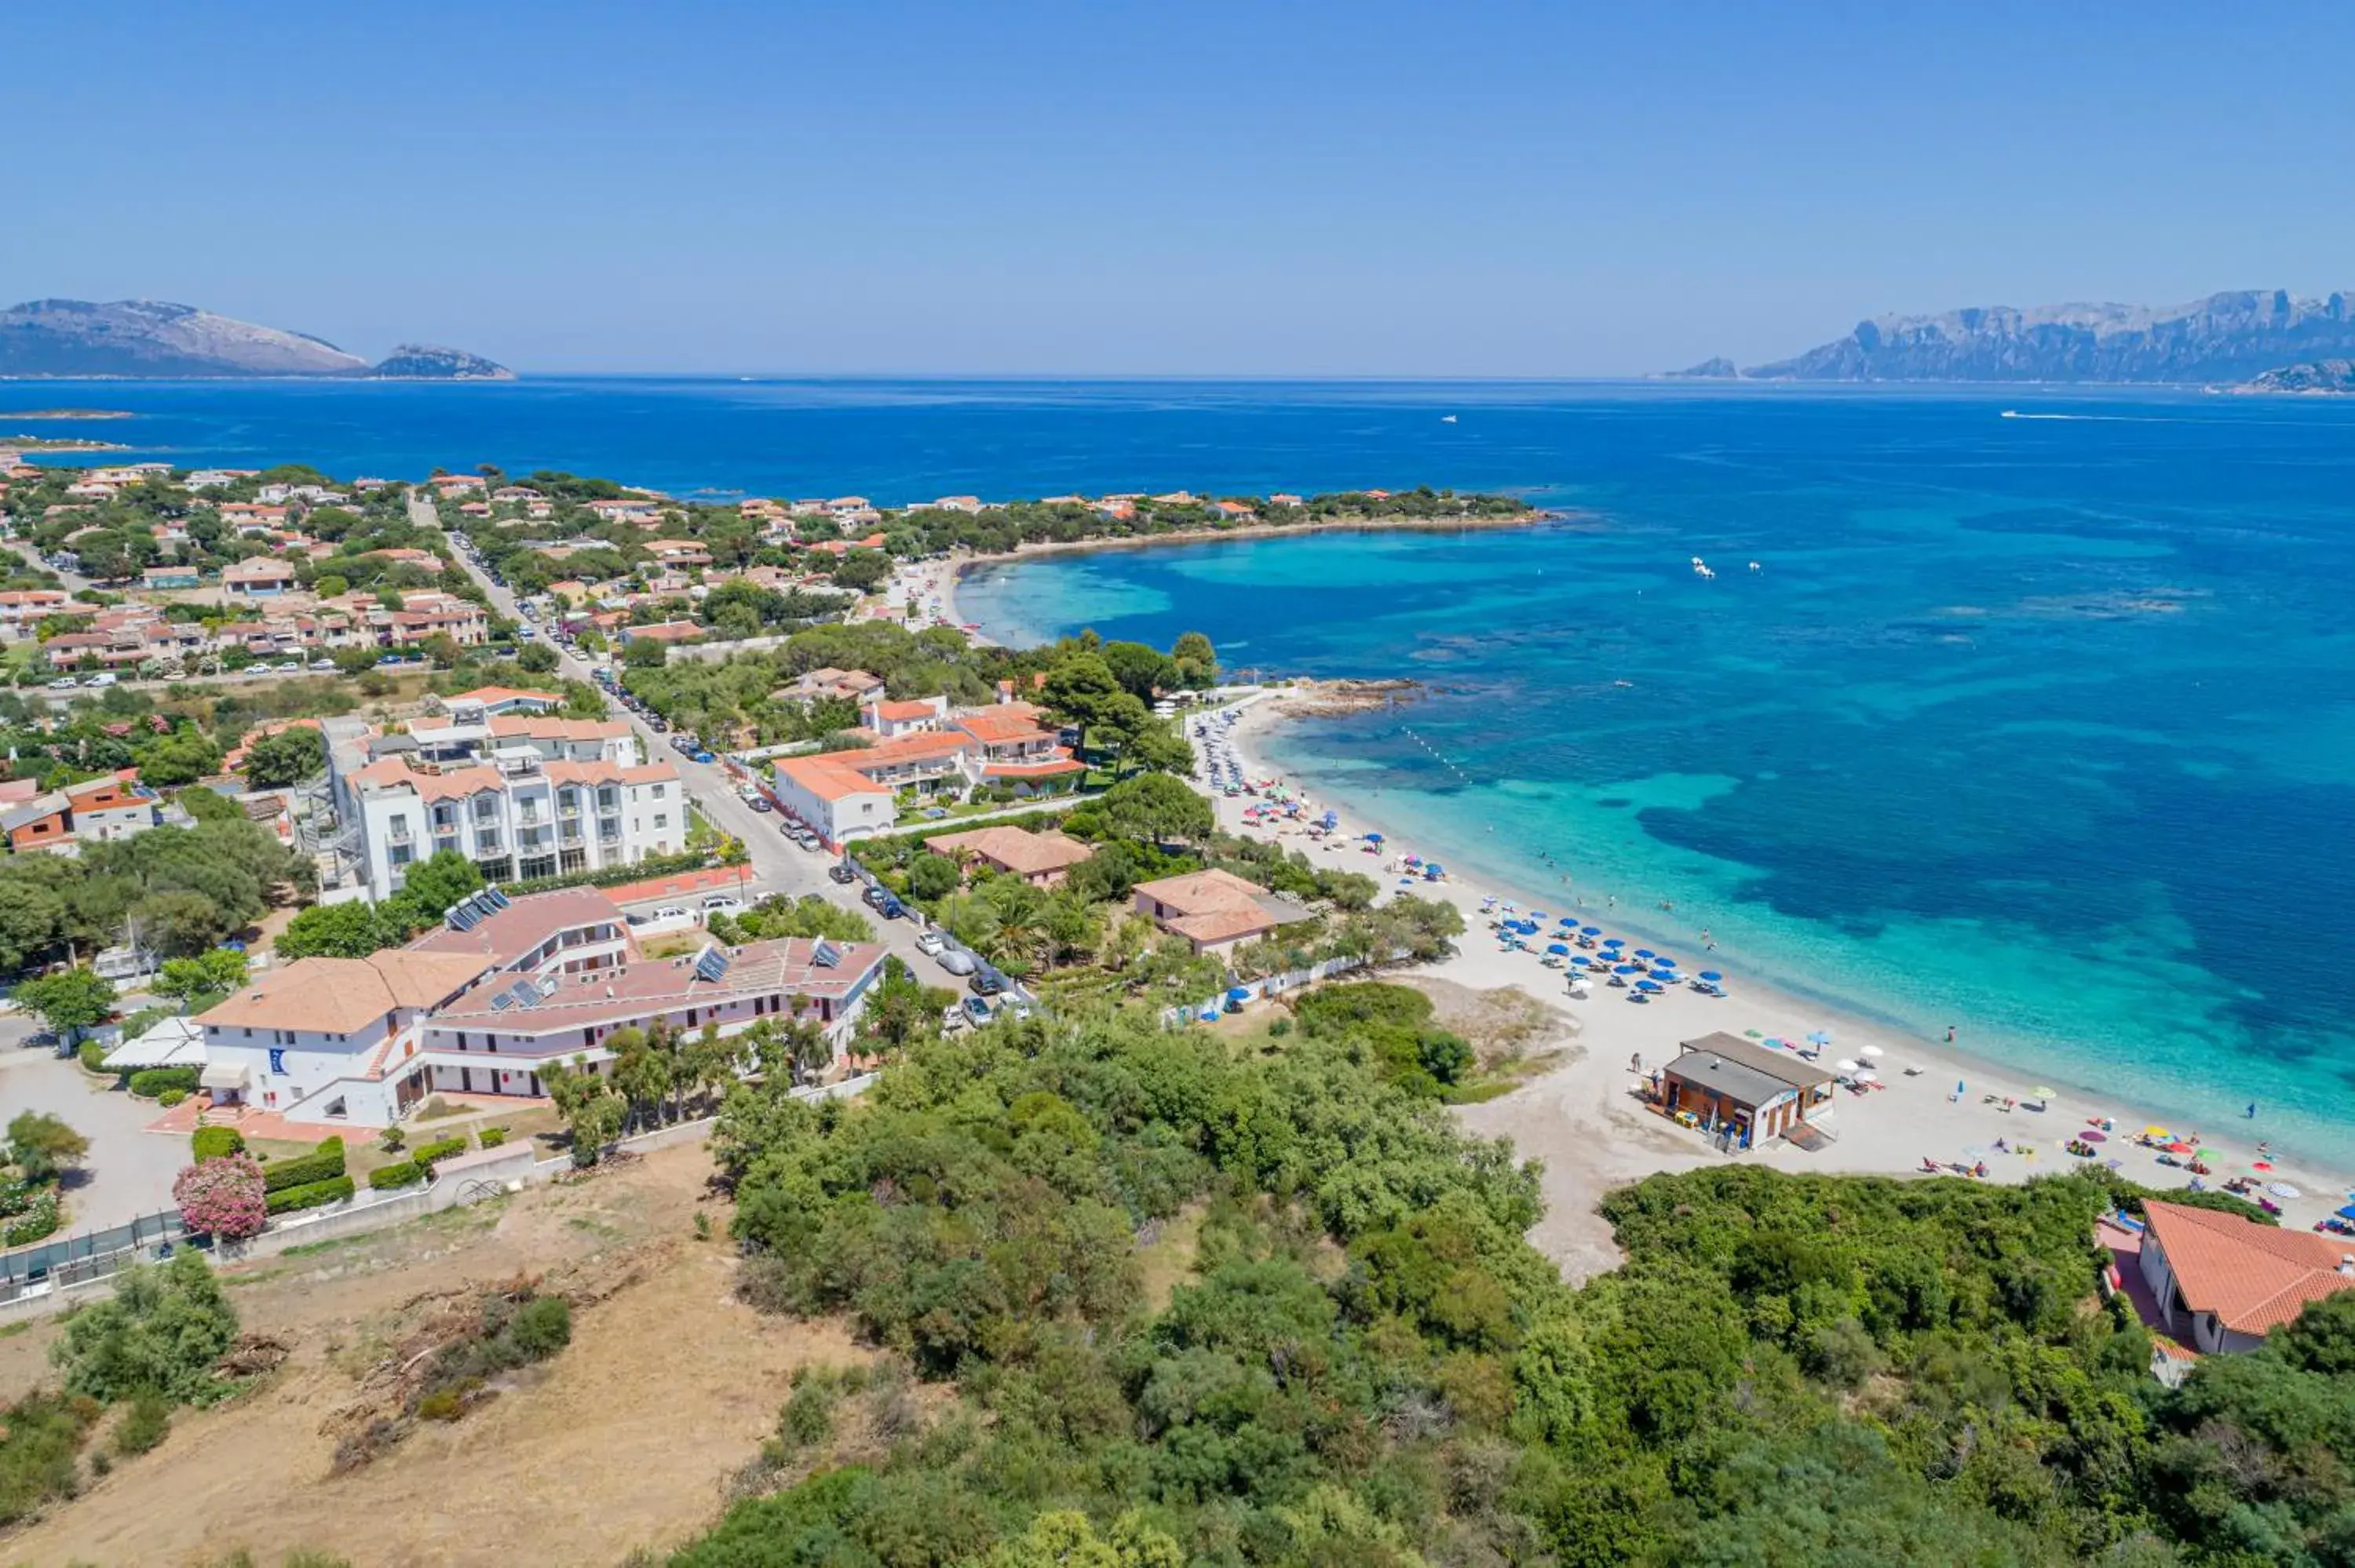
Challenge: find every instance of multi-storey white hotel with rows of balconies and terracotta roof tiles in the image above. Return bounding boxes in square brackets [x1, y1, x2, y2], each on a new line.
[327, 687, 688, 899]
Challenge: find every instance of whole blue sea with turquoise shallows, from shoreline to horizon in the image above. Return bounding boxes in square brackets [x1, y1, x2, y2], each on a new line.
[13, 379, 2355, 1163]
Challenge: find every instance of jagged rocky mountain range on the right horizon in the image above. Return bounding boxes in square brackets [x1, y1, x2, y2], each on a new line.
[1679, 290, 2355, 384]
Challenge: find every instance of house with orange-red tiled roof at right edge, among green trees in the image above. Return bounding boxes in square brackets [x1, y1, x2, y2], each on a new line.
[2141, 1201, 2355, 1354]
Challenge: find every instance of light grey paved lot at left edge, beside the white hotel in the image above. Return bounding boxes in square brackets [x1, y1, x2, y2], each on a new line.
[0, 1017, 188, 1238]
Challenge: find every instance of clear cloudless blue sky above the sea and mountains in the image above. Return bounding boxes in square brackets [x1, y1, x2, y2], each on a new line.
[18, 0, 2355, 374]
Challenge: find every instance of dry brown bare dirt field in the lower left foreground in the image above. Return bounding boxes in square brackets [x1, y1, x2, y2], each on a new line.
[0, 1149, 864, 1568]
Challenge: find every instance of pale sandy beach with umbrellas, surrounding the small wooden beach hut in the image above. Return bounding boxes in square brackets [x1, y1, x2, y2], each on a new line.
[1189, 692, 2350, 1281]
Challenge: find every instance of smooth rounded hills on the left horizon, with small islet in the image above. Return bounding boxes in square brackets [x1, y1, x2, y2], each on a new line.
[0, 299, 516, 381]
